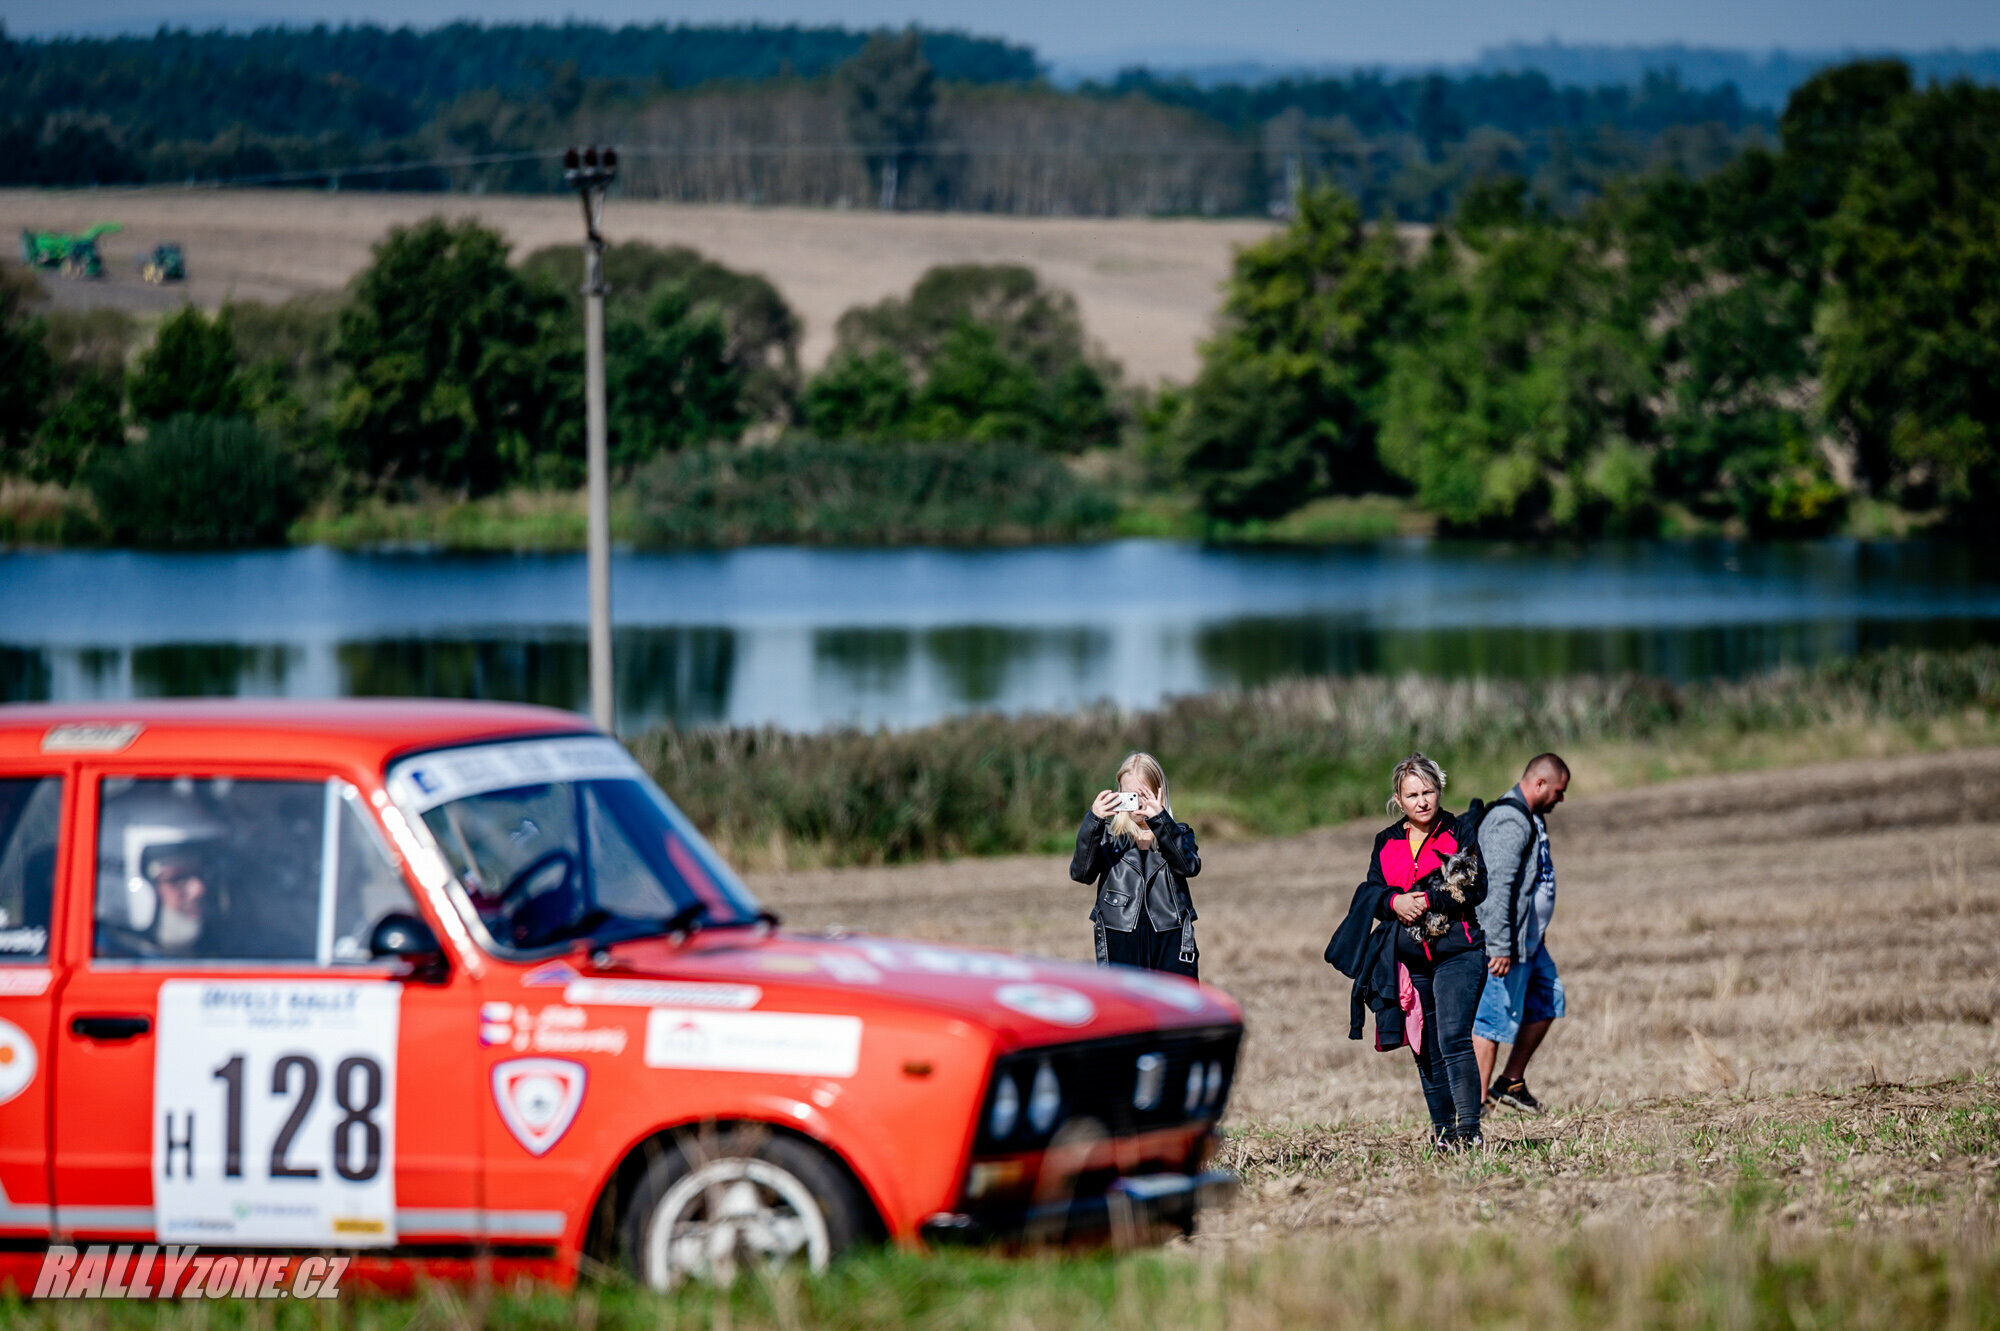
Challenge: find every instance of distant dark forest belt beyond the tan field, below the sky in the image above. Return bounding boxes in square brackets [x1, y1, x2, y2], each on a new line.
[0, 24, 1770, 220]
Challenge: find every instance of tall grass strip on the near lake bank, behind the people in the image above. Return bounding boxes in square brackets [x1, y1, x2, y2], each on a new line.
[634, 648, 2000, 863]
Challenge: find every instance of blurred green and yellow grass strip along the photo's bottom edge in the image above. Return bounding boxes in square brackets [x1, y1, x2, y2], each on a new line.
[0, 1231, 2000, 1331]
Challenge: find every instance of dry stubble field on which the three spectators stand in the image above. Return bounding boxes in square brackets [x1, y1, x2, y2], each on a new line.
[752, 749, 2000, 1241]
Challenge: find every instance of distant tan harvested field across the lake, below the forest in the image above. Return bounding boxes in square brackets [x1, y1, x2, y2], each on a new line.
[0, 190, 1270, 382]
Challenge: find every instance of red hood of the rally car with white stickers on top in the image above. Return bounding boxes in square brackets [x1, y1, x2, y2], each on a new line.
[528, 929, 1242, 1045]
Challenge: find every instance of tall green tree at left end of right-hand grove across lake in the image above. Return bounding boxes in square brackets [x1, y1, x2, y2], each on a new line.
[1178, 186, 1412, 522]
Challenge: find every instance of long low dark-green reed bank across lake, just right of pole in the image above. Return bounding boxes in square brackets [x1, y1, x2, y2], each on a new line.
[636, 444, 1116, 546]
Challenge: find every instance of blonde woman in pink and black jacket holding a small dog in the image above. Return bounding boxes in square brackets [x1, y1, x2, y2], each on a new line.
[1368, 753, 1486, 1147]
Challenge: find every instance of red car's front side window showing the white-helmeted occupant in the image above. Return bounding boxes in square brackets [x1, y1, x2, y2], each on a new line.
[94, 777, 412, 965]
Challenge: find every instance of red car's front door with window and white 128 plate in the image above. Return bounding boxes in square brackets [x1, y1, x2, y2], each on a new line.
[52, 765, 480, 1249]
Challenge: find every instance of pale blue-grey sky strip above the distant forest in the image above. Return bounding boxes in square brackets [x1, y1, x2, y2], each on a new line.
[0, 0, 2000, 64]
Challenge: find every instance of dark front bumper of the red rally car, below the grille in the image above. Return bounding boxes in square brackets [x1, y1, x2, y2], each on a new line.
[922, 1169, 1236, 1245]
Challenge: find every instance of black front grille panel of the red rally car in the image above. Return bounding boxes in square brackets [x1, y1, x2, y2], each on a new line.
[972, 1025, 1242, 1155]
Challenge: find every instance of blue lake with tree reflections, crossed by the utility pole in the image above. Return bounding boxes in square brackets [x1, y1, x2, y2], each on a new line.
[0, 540, 2000, 731]
